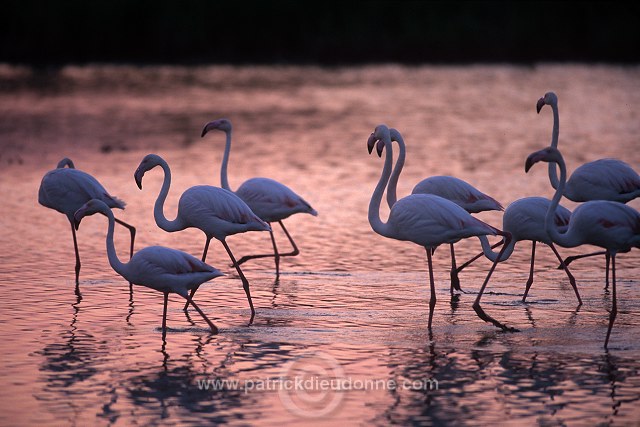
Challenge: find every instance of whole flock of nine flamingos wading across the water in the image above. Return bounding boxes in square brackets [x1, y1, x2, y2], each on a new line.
[38, 92, 640, 348]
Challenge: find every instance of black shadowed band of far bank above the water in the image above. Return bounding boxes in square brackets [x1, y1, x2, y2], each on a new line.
[0, 0, 640, 65]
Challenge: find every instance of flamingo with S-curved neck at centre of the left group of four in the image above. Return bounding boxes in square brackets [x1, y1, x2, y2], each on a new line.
[134, 154, 271, 323]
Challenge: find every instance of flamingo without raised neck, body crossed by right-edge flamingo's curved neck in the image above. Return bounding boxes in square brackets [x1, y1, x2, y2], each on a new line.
[458, 197, 582, 305]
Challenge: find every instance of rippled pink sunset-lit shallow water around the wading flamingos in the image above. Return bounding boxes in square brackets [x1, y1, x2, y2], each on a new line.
[0, 65, 640, 425]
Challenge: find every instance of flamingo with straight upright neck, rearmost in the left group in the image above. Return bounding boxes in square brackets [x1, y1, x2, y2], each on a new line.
[201, 119, 318, 276]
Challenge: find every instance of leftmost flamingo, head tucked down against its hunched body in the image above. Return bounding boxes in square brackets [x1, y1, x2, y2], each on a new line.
[38, 157, 136, 285]
